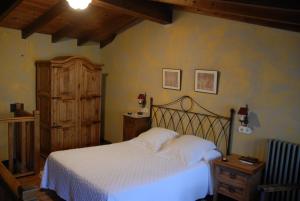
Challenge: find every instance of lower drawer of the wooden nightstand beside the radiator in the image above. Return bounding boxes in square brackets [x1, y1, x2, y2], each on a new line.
[217, 182, 245, 200]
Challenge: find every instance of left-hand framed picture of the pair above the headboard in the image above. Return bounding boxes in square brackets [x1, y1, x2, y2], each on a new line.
[163, 68, 181, 90]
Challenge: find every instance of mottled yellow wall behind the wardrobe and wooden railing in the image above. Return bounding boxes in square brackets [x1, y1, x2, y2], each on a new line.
[0, 27, 100, 160]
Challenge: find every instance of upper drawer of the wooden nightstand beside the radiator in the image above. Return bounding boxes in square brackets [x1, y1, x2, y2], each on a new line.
[217, 167, 248, 187]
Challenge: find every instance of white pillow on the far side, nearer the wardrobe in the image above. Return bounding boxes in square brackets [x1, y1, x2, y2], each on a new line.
[136, 127, 178, 152]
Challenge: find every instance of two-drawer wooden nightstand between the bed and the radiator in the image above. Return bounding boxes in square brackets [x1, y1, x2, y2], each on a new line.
[213, 154, 264, 201]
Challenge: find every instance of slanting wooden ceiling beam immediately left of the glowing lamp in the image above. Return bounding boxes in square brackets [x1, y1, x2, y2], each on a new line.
[22, 0, 68, 39]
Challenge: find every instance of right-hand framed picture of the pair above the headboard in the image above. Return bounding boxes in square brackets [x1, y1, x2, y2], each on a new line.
[195, 70, 218, 94]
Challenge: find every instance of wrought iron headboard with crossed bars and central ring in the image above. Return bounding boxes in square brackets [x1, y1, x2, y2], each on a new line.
[150, 96, 235, 155]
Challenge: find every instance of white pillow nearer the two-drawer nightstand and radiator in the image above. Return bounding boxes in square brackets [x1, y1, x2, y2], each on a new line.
[160, 135, 216, 166]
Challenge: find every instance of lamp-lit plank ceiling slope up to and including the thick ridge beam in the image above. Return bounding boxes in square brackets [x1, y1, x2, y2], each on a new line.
[0, 0, 172, 47]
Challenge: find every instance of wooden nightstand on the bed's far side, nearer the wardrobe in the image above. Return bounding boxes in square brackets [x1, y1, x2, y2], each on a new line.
[123, 113, 150, 141]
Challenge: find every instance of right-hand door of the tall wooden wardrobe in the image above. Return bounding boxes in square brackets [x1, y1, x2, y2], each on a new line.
[79, 62, 101, 147]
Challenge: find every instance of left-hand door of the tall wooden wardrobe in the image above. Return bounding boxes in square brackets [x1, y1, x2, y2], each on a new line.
[51, 61, 79, 151]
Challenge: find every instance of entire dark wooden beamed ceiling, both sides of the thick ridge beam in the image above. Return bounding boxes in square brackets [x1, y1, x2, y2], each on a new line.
[0, 0, 300, 47]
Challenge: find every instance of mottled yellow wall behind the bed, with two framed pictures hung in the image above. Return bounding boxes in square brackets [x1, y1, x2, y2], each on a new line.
[101, 12, 300, 158]
